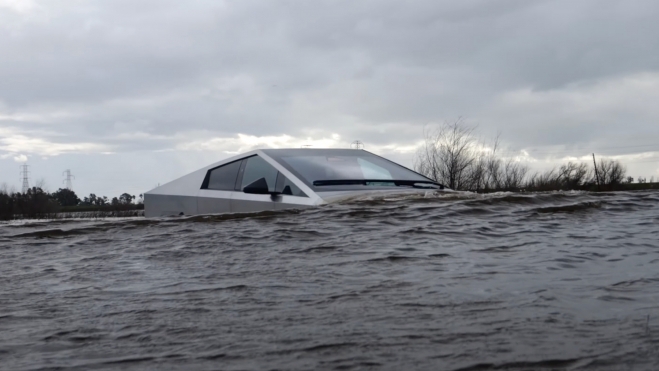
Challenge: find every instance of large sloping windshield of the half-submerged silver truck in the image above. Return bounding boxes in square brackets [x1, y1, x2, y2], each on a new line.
[270, 151, 429, 186]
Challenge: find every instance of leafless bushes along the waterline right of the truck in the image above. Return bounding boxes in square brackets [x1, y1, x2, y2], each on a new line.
[414, 120, 656, 192]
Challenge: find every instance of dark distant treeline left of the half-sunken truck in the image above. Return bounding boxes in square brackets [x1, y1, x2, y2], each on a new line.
[0, 187, 144, 220]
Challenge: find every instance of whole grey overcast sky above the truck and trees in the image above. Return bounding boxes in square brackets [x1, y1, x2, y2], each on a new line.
[0, 0, 659, 198]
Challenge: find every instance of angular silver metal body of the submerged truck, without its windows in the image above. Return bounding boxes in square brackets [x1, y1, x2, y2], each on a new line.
[144, 149, 448, 217]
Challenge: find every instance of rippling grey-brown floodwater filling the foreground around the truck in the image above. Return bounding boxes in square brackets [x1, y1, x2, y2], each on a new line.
[0, 191, 659, 371]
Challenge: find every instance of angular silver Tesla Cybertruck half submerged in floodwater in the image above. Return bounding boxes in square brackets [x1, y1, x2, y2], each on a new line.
[144, 148, 445, 217]
